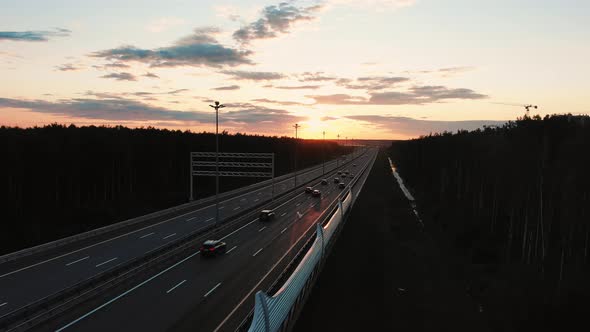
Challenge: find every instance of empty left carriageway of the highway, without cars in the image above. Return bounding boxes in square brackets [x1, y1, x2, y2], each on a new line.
[0, 152, 360, 320]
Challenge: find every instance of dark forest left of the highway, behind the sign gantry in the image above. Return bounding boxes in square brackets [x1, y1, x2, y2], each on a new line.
[0, 124, 350, 254]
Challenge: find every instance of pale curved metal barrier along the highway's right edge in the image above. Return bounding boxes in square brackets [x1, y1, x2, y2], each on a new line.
[238, 149, 375, 332]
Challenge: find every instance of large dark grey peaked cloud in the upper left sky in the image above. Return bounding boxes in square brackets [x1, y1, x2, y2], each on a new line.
[90, 27, 252, 67]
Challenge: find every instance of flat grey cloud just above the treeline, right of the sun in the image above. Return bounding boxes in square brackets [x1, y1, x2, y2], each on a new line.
[345, 115, 506, 137]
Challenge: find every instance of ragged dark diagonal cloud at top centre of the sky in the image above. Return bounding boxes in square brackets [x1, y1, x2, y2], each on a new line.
[233, 2, 322, 44]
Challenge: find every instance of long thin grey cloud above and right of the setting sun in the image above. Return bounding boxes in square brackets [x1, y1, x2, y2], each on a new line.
[306, 85, 488, 105]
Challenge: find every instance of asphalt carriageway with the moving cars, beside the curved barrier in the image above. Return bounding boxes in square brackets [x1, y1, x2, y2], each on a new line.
[39, 149, 376, 331]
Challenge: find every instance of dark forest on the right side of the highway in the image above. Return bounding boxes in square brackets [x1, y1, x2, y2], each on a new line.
[389, 114, 590, 331]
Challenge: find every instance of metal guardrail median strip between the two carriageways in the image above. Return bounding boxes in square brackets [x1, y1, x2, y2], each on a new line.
[0, 152, 364, 331]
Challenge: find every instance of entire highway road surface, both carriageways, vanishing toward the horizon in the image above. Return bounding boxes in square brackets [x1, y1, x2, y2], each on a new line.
[0, 149, 376, 331]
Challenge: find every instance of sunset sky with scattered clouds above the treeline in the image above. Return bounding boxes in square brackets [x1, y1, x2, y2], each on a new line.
[0, 0, 590, 139]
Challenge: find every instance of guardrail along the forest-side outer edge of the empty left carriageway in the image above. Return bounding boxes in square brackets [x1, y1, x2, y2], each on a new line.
[0, 150, 356, 264]
